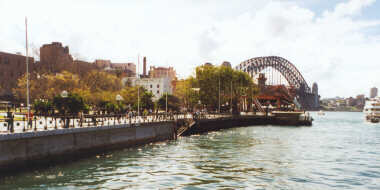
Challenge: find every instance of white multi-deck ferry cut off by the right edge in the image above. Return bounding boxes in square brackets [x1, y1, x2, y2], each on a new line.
[363, 97, 380, 123]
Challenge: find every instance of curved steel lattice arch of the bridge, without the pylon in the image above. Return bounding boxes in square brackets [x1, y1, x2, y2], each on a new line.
[236, 56, 311, 94]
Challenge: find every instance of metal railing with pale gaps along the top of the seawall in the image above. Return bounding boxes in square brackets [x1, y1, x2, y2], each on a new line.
[0, 113, 217, 134]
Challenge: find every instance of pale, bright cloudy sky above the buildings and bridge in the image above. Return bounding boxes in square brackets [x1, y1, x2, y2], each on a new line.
[0, 0, 380, 98]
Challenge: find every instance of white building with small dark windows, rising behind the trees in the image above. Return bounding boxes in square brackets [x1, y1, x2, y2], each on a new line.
[123, 78, 173, 101]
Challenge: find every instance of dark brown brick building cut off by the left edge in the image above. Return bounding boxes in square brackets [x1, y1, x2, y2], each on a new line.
[0, 52, 35, 100]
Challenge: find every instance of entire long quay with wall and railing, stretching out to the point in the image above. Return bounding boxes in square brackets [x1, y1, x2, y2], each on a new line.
[0, 113, 312, 174]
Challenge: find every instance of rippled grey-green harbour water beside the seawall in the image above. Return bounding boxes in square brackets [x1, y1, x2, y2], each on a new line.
[0, 112, 380, 190]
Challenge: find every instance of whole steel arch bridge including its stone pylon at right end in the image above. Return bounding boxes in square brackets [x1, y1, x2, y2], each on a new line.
[236, 56, 319, 110]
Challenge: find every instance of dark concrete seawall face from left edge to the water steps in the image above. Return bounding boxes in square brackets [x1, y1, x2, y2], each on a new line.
[0, 122, 175, 171]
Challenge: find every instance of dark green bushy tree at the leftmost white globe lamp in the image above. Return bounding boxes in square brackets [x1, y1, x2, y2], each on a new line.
[53, 94, 88, 115]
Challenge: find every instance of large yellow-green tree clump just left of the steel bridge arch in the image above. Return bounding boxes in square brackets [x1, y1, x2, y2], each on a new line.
[174, 64, 258, 112]
